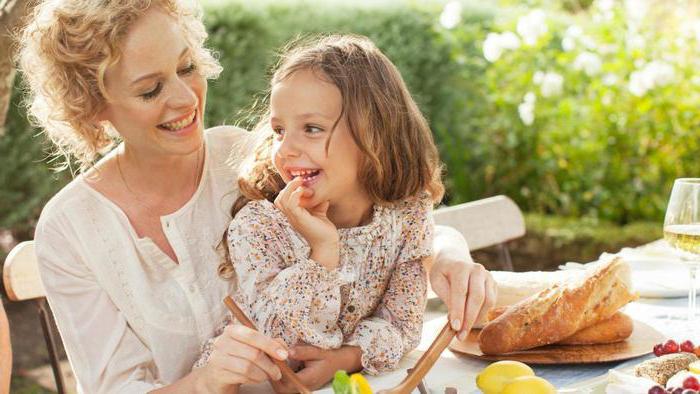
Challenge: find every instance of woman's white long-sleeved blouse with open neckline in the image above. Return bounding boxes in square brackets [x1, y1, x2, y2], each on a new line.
[35, 126, 254, 393]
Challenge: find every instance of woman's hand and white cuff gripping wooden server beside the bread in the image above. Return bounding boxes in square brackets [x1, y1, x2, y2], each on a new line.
[426, 226, 497, 340]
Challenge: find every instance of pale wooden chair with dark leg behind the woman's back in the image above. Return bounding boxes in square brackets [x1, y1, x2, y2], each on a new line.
[2, 241, 65, 394]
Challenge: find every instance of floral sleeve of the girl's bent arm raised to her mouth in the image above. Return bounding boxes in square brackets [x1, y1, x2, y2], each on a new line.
[227, 201, 346, 347]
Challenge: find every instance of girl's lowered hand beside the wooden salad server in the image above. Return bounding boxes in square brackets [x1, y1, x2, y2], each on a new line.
[271, 345, 362, 393]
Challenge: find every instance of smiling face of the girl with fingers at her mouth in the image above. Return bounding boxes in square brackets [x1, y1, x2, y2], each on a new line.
[270, 69, 369, 212]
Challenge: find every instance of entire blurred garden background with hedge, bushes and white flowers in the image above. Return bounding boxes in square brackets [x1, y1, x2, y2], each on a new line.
[0, 0, 700, 388]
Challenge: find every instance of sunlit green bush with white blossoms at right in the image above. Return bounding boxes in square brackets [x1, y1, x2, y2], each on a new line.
[448, 1, 700, 223]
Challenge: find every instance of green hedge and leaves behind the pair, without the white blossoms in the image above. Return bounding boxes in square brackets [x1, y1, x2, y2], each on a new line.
[0, 0, 688, 237]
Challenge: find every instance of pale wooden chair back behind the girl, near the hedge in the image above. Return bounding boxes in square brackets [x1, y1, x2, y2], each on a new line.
[433, 196, 525, 271]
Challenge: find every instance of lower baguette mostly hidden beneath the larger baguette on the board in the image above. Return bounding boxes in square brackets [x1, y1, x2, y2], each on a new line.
[488, 307, 634, 345]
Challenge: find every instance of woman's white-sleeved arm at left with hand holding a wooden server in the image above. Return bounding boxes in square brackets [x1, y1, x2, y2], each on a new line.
[35, 219, 284, 393]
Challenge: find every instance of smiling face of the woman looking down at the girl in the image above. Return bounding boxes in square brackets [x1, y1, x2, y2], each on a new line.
[99, 7, 207, 155]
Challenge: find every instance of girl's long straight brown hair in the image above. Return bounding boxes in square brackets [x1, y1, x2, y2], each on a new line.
[219, 35, 444, 277]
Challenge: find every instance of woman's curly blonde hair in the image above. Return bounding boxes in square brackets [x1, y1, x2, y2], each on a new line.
[17, 0, 221, 171]
